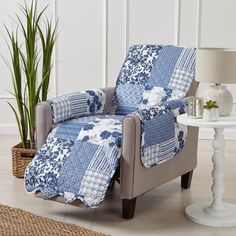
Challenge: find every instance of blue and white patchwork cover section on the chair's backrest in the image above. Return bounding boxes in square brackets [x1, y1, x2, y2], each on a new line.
[110, 45, 196, 115]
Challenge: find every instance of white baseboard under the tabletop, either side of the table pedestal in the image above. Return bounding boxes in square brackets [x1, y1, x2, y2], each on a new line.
[198, 128, 236, 140]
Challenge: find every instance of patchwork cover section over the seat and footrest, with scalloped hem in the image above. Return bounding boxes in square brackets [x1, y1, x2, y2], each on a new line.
[25, 115, 123, 208]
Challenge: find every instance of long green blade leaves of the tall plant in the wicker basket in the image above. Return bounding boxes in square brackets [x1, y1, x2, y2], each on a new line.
[6, 0, 57, 148]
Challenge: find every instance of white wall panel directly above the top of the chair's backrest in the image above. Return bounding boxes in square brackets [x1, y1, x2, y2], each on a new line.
[128, 0, 175, 45]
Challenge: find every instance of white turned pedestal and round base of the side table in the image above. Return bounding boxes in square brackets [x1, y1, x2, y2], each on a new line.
[185, 128, 236, 227]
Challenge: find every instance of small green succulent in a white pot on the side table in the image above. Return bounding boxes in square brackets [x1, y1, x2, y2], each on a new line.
[203, 100, 219, 121]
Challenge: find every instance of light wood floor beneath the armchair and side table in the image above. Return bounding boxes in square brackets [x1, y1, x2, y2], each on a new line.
[0, 135, 236, 236]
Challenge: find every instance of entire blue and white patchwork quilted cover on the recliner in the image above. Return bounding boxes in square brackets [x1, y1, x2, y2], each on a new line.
[25, 45, 196, 208]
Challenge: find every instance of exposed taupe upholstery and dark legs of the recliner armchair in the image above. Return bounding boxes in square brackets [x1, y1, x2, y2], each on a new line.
[30, 45, 198, 219]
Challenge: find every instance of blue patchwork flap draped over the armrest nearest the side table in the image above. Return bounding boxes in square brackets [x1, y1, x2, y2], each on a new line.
[135, 99, 187, 168]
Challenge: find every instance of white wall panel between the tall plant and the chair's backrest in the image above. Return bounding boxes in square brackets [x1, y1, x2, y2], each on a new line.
[57, 0, 105, 94]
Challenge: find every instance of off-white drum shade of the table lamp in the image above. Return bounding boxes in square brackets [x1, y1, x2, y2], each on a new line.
[196, 48, 236, 84]
